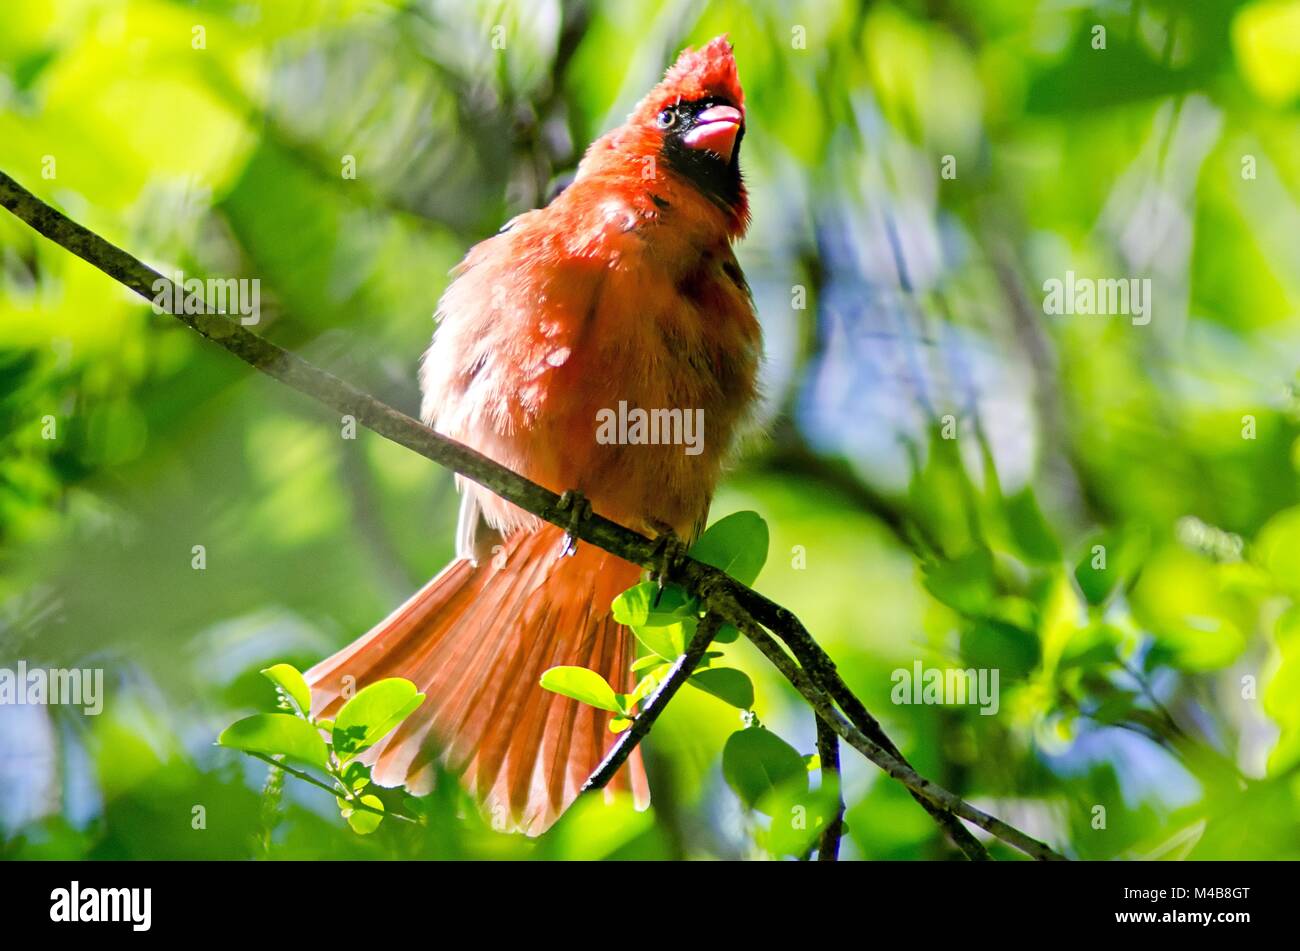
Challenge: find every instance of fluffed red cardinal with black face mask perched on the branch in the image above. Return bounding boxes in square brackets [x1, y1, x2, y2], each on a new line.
[307, 36, 762, 834]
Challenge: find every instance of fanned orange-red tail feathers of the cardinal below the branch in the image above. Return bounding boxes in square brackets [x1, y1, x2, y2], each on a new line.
[307, 526, 649, 834]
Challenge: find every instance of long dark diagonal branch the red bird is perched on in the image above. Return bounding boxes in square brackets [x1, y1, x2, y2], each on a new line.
[0, 171, 1062, 859]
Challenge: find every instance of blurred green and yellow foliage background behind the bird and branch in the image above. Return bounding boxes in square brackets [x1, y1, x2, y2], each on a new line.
[0, 0, 1300, 859]
